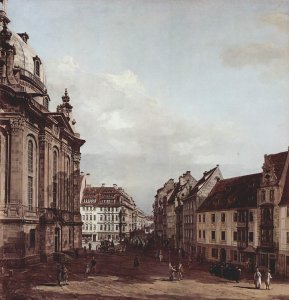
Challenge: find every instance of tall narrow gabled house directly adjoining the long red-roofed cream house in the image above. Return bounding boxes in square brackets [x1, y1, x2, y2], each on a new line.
[182, 166, 223, 255]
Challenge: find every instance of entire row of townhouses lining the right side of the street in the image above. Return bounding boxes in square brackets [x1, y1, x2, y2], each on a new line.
[153, 151, 289, 276]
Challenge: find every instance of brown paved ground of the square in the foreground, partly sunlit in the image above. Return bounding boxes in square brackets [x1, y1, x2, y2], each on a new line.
[2, 253, 289, 299]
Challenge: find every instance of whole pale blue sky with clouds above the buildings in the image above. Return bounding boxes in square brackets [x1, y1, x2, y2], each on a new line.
[8, 0, 289, 214]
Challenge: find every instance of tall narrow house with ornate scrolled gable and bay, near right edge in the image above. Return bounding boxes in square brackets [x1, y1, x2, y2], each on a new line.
[258, 151, 288, 274]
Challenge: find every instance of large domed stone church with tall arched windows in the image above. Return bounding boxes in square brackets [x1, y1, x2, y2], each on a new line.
[0, 1, 85, 265]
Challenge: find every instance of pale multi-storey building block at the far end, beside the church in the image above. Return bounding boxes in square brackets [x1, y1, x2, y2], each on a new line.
[80, 178, 147, 242]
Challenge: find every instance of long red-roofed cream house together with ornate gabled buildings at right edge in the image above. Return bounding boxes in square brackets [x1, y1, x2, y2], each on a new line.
[195, 151, 289, 276]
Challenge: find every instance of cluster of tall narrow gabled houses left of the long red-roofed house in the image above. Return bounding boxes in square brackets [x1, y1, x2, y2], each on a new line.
[153, 165, 222, 254]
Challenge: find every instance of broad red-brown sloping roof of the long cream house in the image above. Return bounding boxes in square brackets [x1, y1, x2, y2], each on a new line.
[197, 173, 262, 212]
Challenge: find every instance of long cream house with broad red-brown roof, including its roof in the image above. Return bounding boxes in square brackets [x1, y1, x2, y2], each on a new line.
[196, 174, 262, 268]
